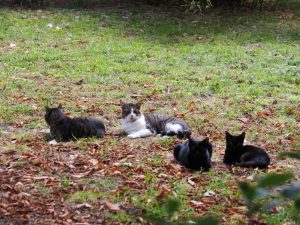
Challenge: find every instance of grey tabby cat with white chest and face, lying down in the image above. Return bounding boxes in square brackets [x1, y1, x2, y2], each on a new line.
[121, 101, 191, 138]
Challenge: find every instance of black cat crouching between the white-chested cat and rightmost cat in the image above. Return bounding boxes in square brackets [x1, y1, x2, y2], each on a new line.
[174, 138, 212, 171]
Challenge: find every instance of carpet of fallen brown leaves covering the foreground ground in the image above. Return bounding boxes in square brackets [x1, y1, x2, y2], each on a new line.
[0, 99, 296, 224]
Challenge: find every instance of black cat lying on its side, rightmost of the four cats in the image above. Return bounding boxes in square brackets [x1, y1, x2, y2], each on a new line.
[223, 131, 270, 169]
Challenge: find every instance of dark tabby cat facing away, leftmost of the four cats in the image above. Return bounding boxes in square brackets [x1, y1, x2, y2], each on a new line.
[45, 105, 105, 141]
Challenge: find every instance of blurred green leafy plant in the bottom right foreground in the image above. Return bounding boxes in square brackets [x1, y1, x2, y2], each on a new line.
[239, 151, 300, 225]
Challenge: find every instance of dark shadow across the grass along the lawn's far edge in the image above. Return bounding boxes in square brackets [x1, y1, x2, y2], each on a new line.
[1, 0, 300, 45]
